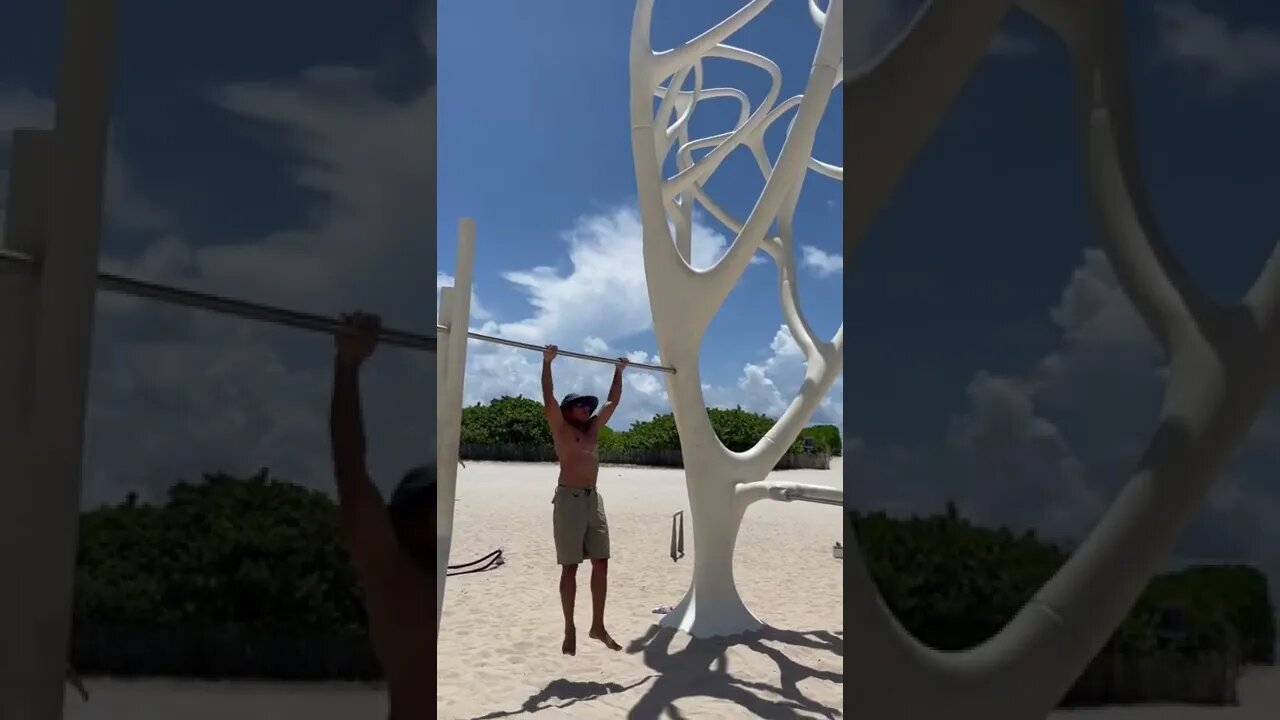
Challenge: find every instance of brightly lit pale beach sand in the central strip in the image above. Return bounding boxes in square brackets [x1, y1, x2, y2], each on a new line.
[436, 462, 844, 720]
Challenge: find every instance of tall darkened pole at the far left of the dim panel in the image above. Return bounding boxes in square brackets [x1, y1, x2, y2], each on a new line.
[0, 0, 116, 720]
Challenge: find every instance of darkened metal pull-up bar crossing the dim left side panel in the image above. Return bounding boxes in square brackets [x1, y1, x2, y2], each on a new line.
[0, 250, 435, 352]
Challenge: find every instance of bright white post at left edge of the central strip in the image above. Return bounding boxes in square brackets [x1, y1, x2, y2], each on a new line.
[435, 218, 476, 628]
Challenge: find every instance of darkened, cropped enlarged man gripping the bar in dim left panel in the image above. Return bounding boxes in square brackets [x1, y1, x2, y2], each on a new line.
[329, 313, 436, 720]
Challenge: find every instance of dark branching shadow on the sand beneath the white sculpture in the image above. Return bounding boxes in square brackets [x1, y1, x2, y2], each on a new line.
[472, 625, 845, 720]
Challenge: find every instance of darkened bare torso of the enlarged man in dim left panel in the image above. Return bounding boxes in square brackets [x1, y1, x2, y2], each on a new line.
[362, 553, 435, 720]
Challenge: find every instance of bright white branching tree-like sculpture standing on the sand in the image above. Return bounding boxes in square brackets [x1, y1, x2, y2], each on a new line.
[631, 0, 845, 637]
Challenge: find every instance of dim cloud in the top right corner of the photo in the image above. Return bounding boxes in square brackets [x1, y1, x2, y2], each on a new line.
[1155, 1, 1280, 94]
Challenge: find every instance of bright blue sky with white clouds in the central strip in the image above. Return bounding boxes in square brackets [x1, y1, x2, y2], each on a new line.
[438, 0, 842, 428]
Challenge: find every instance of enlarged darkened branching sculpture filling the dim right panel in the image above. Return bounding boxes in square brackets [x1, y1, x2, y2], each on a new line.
[845, 0, 1280, 720]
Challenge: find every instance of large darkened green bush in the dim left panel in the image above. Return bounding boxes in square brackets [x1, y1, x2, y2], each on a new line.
[74, 470, 365, 628]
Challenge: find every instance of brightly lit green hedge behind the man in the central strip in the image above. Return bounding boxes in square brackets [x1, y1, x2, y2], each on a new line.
[462, 396, 841, 455]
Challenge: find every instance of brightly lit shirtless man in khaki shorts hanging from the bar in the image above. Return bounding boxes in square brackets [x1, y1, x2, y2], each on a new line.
[543, 345, 627, 655]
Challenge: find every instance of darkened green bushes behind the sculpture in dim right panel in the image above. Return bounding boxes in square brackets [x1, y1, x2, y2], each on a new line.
[854, 503, 1276, 664]
